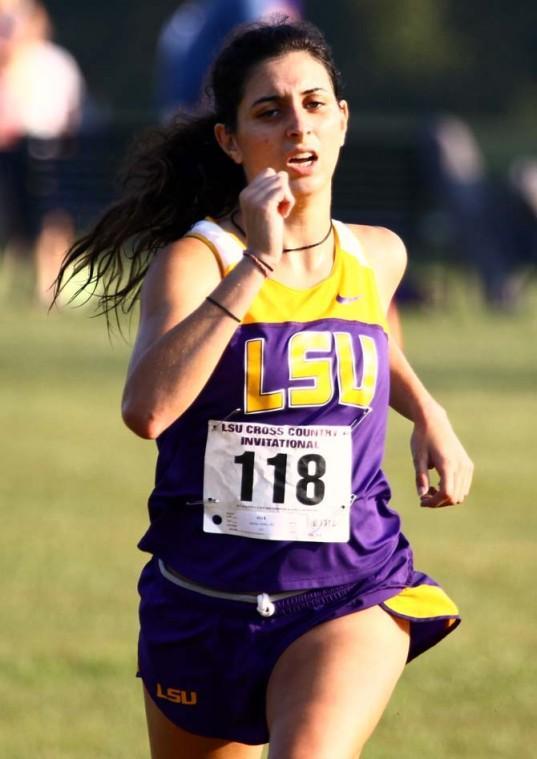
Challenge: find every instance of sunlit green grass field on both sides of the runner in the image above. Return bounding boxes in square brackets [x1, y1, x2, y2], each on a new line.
[0, 276, 537, 759]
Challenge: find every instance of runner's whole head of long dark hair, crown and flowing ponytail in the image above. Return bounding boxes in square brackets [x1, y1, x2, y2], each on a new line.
[54, 19, 341, 317]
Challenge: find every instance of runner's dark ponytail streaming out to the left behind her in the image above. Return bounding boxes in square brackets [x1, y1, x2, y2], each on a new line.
[54, 114, 244, 318]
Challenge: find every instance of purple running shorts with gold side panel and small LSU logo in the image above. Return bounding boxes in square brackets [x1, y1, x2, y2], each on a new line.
[138, 557, 460, 744]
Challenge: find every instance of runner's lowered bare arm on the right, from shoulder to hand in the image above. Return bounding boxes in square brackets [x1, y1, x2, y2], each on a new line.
[355, 227, 473, 508]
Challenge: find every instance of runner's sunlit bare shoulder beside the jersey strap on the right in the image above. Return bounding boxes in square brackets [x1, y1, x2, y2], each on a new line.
[349, 224, 407, 305]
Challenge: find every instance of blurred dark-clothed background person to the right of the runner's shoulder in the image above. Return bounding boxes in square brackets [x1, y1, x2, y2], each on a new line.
[419, 115, 537, 309]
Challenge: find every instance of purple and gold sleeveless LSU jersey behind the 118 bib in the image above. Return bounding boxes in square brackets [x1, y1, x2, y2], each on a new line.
[136, 220, 411, 592]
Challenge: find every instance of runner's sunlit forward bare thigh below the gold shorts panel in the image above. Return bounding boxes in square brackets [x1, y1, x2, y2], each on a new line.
[267, 606, 409, 759]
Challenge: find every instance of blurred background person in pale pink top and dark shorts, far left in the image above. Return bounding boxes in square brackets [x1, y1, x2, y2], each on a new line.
[0, 0, 85, 304]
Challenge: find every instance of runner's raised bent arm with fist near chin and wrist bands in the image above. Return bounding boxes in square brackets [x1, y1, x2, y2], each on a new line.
[122, 170, 293, 438]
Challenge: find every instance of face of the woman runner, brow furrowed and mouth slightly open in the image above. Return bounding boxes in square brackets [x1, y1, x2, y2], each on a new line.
[217, 52, 348, 195]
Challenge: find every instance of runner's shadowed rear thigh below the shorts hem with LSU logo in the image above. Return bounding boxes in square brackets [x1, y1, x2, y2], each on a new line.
[144, 688, 262, 759]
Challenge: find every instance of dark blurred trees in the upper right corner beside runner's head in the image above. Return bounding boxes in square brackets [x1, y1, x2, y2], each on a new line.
[307, 0, 537, 116]
